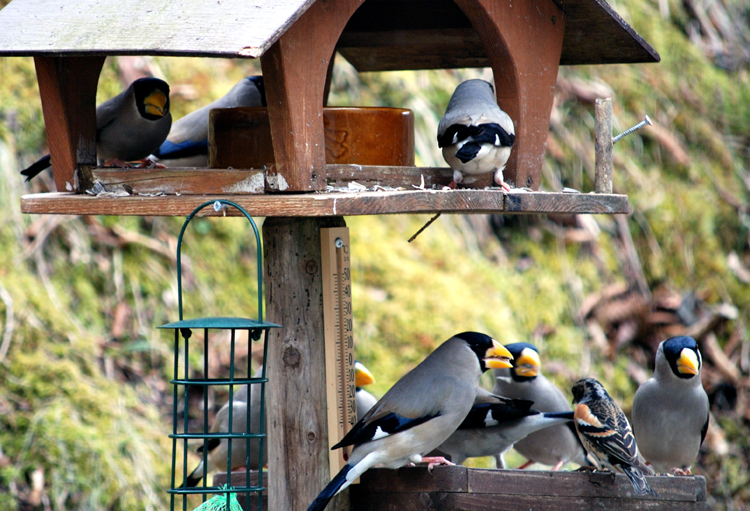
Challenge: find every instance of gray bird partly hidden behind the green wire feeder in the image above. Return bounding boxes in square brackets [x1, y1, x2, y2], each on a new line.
[184, 382, 268, 488]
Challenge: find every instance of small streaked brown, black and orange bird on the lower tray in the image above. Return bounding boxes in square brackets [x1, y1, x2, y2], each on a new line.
[573, 378, 657, 496]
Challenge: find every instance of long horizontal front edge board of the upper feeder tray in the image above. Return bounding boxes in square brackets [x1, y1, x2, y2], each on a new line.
[21, 190, 630, 217]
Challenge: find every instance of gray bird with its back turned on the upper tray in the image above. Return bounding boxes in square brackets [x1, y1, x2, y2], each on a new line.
[438, 80, 516, 190]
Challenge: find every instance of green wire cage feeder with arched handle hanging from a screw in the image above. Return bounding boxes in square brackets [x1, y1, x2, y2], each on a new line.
[159, 200, 281, 511]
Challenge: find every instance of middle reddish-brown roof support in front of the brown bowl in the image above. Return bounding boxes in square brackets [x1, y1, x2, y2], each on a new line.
[260, 0, 363, 192]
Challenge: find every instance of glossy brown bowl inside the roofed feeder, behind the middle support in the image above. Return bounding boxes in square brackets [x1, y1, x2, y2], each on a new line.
[208, 107, 414, 169]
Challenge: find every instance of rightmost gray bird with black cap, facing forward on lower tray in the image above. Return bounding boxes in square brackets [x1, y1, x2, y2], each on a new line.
[632, 336, 709, 475]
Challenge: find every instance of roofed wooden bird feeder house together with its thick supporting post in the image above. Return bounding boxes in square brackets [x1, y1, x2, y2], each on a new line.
[0, 0, 705, 510]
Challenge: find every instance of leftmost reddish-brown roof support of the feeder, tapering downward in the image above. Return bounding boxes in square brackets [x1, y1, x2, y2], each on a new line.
[34, 57, 104, 192]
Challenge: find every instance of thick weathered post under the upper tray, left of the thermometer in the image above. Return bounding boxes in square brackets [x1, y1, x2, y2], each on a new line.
[263, 217, 349, 511]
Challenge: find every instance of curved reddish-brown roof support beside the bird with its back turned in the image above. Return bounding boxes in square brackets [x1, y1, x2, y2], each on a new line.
[455, 0, 565, 190]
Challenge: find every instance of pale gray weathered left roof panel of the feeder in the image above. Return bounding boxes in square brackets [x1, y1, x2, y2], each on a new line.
[0, 0, 315, 58]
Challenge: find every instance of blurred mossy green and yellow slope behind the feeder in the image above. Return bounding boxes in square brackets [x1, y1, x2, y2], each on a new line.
[0, 0, 750, 510]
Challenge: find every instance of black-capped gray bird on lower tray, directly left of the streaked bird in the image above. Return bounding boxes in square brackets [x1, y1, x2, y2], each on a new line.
[492, 342, 588, 470]
